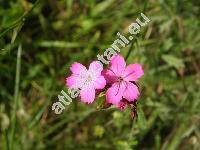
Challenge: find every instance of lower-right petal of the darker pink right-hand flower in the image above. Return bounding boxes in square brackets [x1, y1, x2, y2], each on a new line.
[123, 82, 140, 102]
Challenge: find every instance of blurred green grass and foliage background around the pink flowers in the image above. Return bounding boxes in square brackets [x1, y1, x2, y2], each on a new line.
[0, 0, 200, 150]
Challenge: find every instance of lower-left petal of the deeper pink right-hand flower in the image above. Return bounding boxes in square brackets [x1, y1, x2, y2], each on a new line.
[106, 83, 125, 105]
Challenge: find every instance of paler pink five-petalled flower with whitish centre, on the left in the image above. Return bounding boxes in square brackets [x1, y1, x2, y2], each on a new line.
[66, 61, 106, 103]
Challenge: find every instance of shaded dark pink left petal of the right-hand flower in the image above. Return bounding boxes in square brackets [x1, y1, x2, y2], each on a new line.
[102, 69, 118, 84]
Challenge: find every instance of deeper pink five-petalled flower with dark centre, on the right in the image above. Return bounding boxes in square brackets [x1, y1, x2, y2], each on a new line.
[103, 55, 144, 105]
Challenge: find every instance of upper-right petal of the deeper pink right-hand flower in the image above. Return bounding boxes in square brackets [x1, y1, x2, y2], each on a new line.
[123, 64, 144, 81]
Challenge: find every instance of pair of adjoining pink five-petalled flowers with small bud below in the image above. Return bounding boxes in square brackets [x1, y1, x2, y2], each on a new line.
[66, 55, 144, 110]
